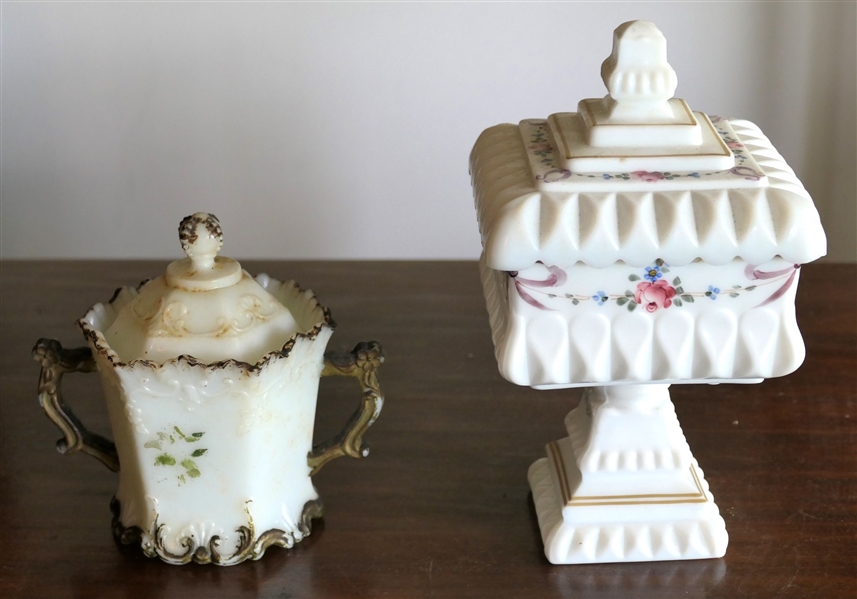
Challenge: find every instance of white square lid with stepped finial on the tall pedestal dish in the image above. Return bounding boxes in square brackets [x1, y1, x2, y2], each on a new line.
[470, 21, 827, 271]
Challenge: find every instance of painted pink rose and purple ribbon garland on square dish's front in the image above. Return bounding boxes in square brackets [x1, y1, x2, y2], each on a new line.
[507, 259, 800, 313]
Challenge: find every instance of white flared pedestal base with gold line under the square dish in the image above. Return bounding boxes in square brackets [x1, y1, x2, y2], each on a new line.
[528, 385, 729, 564]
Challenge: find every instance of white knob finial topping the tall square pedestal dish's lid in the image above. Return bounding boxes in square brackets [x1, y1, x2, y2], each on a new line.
[601, 21, 678, 122]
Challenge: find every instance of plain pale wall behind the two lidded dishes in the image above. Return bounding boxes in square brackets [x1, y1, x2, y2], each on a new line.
[0, 2, 857, 261]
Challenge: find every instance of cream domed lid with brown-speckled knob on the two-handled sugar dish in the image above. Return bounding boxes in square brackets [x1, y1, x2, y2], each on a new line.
[104, 212, 300, 364]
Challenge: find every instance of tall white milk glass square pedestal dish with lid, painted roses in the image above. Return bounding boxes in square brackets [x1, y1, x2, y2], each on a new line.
[471, 21, 826, 564]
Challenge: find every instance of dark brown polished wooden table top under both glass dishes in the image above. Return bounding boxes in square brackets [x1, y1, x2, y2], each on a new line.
[0, 261, 857, 599]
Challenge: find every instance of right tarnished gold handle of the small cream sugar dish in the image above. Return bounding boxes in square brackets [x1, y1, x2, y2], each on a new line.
[307, 341, 384, 476]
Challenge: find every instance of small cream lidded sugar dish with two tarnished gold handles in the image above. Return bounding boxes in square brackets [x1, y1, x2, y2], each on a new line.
[33, 213, 384, 565]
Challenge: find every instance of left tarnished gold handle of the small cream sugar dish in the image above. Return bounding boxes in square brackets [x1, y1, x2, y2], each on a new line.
[33, 339, 119, 472]
